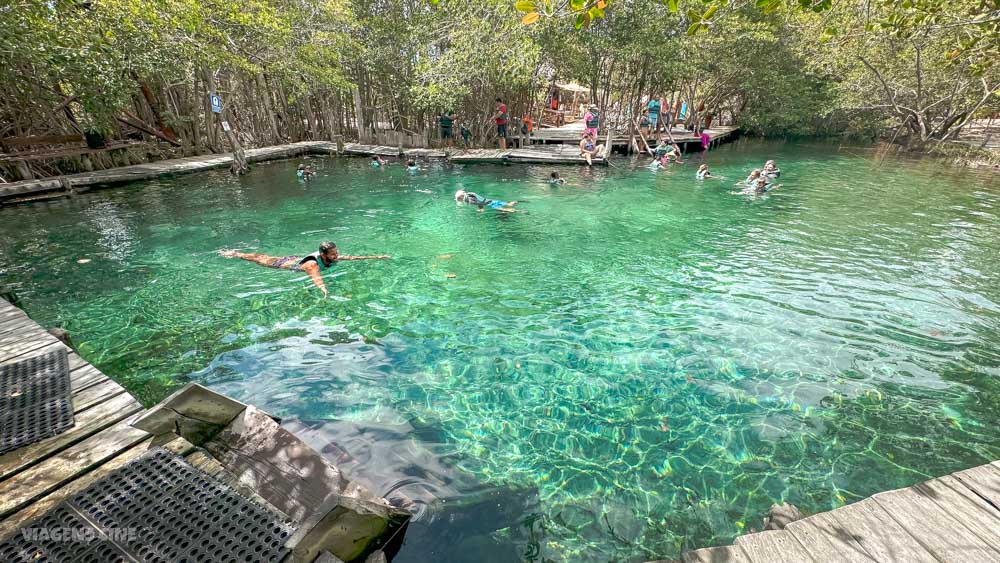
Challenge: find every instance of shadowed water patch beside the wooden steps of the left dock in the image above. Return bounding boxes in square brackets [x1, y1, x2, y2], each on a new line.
[282, 419, 542, 563]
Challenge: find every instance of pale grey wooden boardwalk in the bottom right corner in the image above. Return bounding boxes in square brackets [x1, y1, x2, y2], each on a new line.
[652, 462, 1000, 563]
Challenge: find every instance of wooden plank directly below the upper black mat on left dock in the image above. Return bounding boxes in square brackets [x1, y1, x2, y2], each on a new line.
[0, 393, 142, 481]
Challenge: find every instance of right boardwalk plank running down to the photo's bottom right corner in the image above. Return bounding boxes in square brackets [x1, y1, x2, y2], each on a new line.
[872, 487, 1000, 563]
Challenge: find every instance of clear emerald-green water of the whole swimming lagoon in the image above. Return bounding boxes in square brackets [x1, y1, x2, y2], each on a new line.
[0, 142, 1000, 561]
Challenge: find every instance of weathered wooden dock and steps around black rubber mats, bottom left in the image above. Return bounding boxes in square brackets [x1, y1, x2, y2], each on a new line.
[0, 299, 410, 563]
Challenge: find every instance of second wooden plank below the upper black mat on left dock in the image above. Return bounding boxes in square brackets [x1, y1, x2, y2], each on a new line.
[0, 421, 149, 517]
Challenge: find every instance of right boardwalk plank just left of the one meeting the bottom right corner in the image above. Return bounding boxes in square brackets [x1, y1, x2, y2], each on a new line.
[830, 499, 939, 563]
